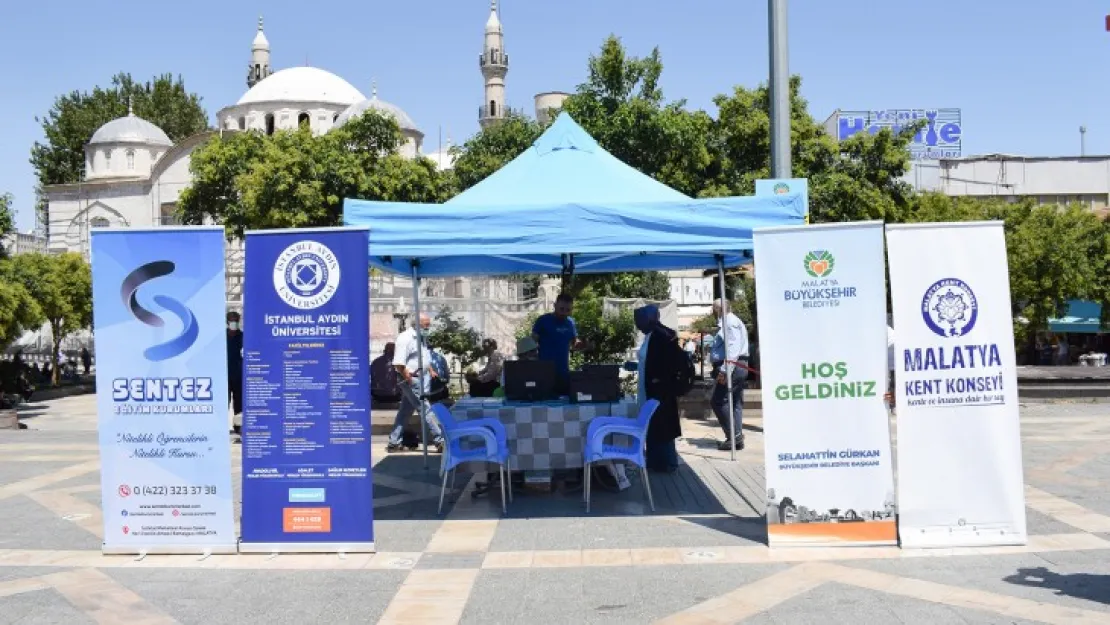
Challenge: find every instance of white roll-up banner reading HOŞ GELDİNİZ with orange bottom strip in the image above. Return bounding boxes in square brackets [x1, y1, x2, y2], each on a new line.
[754, 222, 897, 546]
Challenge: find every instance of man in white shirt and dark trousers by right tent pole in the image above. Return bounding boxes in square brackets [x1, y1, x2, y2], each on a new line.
[709, 300, 748, 451]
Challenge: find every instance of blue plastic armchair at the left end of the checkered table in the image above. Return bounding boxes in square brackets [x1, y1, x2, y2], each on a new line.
[432, 404, 513, 514]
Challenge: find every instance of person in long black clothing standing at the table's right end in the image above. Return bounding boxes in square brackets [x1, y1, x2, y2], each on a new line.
[633, 305, 687, 473]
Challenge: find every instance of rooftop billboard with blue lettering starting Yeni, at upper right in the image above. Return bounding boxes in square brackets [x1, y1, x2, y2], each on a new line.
[829, 109, 963, 161]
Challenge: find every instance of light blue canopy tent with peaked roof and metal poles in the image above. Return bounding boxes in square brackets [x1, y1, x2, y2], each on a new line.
[343, 113, 807, 462]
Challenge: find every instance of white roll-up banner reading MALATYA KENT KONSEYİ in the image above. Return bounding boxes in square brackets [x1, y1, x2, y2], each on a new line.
[887, 222, 1027, 547]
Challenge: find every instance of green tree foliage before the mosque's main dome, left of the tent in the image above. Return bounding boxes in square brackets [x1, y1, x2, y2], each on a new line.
[178, 111, 451, 236]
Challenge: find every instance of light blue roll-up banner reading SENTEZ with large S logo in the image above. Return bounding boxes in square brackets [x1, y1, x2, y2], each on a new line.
[92, 228, 235, 554]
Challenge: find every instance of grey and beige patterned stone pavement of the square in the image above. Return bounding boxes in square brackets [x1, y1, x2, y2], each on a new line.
[0, 396, 1110, 625]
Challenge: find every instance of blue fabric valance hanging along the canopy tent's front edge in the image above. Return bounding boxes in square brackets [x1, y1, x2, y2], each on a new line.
[343, 194, 806, 276]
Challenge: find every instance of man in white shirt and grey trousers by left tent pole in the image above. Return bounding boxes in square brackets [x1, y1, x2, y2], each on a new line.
[385, 313, 443, 452]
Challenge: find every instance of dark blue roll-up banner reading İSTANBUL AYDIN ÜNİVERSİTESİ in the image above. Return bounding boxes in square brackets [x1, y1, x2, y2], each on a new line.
[240, 229, 374, 552]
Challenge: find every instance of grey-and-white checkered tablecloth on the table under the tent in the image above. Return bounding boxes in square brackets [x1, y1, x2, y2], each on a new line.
[451, 400, 639, 471]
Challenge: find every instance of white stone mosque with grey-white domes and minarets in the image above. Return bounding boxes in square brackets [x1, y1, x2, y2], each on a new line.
[43, 0, 565, 260]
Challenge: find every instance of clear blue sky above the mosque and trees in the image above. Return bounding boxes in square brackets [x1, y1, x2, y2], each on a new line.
[0, 0, 1110, 229]
